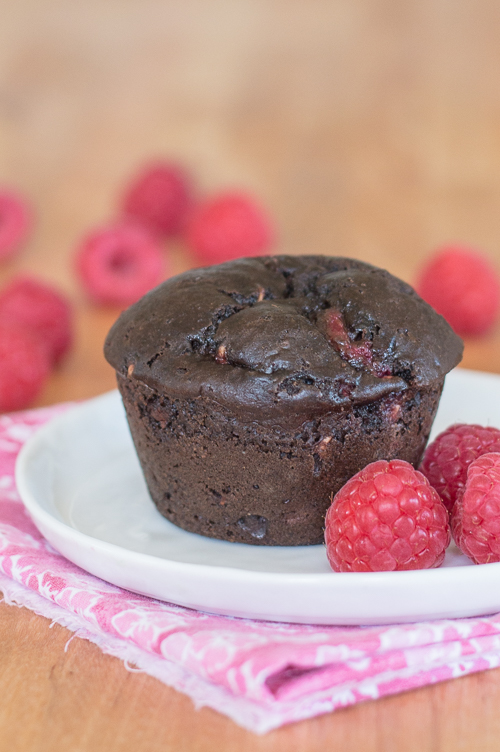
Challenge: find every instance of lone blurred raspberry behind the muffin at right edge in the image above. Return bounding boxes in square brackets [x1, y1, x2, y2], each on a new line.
[417, 246, 500, 336]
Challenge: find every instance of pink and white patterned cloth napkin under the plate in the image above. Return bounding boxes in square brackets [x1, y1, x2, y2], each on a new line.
[0, 405, 500, 733]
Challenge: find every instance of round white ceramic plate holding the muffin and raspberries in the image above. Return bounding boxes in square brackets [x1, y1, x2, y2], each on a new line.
[16, 370, 500, 624]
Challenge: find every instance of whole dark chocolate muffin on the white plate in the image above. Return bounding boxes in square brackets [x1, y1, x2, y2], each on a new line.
[105, 256, 462, 546]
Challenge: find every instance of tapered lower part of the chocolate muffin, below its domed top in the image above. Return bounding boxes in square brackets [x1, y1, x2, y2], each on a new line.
[117, 374, 444, 546]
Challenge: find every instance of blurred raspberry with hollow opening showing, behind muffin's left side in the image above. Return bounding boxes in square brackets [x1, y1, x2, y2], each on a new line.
[76, 224, 163, 305]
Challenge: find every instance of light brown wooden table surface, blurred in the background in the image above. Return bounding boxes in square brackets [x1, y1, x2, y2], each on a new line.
[0, 0, 500, 752]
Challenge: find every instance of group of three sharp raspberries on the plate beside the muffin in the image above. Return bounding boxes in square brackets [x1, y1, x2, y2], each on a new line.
[325, 424, 500, 572]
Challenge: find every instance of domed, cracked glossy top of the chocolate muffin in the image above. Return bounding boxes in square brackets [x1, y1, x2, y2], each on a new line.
[104, 256, 463, 420]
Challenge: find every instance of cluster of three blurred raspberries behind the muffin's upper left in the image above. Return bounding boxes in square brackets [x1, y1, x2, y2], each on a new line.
[76, 162, 274, 306]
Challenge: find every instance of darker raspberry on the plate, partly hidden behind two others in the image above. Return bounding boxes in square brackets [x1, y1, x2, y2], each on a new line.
[419, 423, 500, 512]
